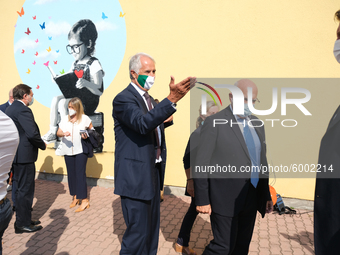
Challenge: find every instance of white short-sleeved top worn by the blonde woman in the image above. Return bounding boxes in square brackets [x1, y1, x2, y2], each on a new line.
[55, 114, 91, 156]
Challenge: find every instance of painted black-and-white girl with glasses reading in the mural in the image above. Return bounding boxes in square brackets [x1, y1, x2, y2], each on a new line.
[42, 19, 105, 143]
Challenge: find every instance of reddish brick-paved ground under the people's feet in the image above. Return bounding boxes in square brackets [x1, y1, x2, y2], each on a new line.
[3, 180, 314, 255]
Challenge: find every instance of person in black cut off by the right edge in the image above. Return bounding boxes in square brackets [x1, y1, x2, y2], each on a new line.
[314, 10, 340, 255]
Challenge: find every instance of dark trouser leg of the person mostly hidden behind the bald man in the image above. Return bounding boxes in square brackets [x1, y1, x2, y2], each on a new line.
[177, 197, 198, 247]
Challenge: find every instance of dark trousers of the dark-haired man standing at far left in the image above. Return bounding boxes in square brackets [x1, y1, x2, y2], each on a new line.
[13, 163, 35, 227]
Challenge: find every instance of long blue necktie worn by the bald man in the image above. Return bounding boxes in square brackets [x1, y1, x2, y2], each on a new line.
[243, 121, 259, 188]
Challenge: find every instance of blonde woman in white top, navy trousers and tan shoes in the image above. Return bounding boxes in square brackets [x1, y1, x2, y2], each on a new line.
[56, 97, 93, 212]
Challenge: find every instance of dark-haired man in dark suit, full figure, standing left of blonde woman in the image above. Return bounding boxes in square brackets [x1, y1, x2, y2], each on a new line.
[6, 84, 46, 233]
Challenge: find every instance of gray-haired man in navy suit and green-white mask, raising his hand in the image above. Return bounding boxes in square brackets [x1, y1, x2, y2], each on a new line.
[112, 53, 190, 255]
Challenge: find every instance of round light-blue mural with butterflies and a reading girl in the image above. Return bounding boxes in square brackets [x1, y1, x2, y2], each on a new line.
[14, 0, 126, 152]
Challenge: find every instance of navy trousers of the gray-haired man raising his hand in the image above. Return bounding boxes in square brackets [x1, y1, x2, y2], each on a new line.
[120, 164, 160, 255]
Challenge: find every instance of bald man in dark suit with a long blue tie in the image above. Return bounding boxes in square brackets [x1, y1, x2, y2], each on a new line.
[192, 79, 273, 254]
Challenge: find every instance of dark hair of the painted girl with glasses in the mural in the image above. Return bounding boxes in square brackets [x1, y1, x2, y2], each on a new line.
[68, 19, 98, 55]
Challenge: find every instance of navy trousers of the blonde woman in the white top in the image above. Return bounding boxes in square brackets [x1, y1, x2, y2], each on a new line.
[64, 153, 87, 199]
